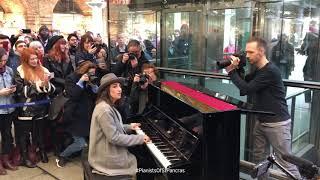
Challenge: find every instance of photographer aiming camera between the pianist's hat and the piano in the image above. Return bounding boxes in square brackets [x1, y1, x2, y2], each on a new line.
[130, 64, 160, 115]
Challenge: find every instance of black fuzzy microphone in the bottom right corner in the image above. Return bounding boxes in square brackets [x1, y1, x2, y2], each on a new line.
[282, 154, 320, 178]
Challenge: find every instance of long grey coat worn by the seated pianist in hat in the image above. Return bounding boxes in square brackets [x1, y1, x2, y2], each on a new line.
[88, 101, 144, 176]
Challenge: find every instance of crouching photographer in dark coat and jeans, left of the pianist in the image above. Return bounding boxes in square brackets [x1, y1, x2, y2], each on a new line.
[56, 61, 98, 168]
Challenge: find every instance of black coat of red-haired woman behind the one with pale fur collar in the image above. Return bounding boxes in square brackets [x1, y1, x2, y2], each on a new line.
[43, 56, 73, 94]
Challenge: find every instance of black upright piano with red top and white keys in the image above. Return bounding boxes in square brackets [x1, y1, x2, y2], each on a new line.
[134, 81, 243, 180]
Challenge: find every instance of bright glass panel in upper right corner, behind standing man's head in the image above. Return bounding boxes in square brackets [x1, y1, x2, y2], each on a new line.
[260, 0, 320, 81]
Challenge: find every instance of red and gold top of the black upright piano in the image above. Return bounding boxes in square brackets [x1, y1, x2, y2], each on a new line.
[161, 81, 238, 113]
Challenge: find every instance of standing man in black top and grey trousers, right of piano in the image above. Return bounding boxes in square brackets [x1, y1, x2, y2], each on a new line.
[226, 37, 301, 179]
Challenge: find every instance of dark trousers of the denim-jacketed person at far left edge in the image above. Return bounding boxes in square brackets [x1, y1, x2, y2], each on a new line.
[0, 113, 16, 154]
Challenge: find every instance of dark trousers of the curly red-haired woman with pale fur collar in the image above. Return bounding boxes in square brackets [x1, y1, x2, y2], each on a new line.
[14, 119, 47, 152]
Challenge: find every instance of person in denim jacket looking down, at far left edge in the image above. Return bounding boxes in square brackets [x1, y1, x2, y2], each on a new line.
[0, 48, 18, 175]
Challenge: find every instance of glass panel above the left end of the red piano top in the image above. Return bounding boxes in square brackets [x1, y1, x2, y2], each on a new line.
[162, 10, 202, 70]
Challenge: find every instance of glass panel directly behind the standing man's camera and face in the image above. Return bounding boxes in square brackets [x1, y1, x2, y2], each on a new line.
[206, 8, 251, 72]
